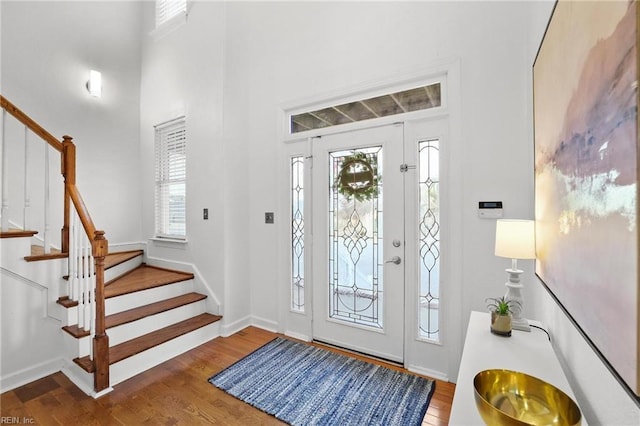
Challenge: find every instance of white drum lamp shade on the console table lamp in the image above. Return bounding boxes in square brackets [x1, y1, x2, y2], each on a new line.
[495, 219, 536, 259]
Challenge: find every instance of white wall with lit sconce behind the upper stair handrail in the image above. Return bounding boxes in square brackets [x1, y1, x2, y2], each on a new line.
[1, 1, 140, 244]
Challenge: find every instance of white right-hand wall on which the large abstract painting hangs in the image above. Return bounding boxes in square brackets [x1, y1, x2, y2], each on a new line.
[527, 2, 640, 425]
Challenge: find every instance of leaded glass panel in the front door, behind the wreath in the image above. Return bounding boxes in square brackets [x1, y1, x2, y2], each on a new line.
[328, 146, 384, 329]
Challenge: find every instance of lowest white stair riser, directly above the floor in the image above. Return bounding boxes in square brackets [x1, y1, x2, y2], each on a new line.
[109, 322, 220, 386]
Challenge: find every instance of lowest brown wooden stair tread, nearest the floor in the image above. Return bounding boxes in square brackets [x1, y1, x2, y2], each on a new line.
[74, 313, 222, 373]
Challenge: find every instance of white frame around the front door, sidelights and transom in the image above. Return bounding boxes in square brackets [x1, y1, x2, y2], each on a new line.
[276, 59, 464, 380]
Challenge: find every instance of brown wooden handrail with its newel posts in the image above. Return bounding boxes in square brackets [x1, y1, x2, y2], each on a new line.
[0, 95, 109, 392]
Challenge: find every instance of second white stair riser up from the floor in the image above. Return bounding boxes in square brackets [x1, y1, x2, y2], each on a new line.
[107, 300, 205, 346]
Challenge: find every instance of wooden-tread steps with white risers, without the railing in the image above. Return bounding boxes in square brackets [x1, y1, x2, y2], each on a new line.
[60, 250, 222, 392]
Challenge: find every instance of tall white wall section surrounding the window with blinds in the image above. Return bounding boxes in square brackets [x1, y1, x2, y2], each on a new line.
[140, 2, 234, 323]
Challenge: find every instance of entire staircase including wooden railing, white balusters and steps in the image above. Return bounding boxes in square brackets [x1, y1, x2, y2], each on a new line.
[0, 95, 221, 397]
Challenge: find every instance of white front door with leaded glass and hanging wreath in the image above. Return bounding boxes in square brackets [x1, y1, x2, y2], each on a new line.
[312, 124, 405, 362]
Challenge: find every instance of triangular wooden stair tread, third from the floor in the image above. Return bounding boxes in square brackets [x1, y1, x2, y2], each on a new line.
[104, 264, 193, 299]
